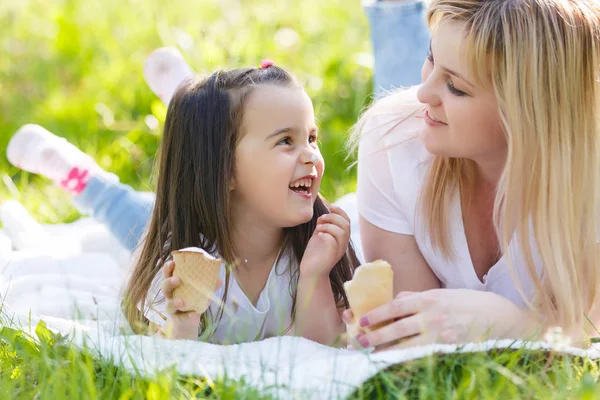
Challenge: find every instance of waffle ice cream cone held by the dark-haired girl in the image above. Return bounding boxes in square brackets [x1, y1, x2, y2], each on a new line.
[171, 247, 221, 314]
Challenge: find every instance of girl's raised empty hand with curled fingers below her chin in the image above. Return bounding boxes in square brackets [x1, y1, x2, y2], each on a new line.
[300, 205, 350, 277]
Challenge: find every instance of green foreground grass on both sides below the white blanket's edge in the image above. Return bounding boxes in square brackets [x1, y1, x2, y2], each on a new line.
[0, 323, 600, 399]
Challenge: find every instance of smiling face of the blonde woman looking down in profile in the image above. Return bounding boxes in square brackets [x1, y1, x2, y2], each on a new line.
[417, 22, 506, 165]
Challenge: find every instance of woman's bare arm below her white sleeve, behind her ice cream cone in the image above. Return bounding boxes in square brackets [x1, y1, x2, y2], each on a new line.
[360, 216, 440, 296]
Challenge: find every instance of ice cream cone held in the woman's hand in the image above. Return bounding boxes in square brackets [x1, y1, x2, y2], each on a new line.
[344, 260, 394, 337]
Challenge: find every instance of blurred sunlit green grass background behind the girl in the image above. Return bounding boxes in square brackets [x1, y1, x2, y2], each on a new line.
[0, 0, 372, 222]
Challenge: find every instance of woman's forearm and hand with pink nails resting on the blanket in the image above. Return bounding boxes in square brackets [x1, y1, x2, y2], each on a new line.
[343, 289, 541, 351]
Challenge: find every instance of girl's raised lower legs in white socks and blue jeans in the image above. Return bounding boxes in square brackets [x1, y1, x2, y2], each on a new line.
[7, 48, 193, 250]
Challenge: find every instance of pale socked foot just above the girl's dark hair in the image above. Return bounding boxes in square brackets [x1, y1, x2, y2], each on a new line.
[144, 47, 194, 105]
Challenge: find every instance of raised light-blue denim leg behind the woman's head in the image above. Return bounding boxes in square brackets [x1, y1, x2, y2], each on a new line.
[365, 0, 430, 95]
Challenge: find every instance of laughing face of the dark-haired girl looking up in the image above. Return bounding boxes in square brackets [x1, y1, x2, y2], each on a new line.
[232, 85, 325, 228]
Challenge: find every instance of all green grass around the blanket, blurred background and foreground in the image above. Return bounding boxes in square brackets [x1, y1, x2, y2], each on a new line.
[0, 0, 600, 399]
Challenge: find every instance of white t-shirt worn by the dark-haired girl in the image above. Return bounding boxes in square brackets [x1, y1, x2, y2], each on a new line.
[145, 247, 297, 344]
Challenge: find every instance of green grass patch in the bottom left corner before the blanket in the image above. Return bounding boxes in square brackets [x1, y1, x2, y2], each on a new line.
[0, 323, 268, 400]
